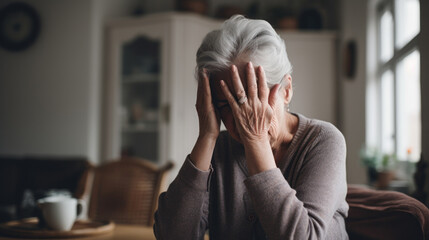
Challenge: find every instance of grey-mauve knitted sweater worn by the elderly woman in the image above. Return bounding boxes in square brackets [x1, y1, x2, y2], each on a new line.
[154, 114, 348, 240]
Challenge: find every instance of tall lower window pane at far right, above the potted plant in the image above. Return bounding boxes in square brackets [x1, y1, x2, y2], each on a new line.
[397, 50, 421, 161]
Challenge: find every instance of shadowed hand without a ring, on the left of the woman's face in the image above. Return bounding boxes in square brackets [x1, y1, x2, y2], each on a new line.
[195, 69, 220, 139]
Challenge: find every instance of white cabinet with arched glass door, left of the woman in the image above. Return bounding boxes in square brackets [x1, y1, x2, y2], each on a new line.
[102, 13, 220, 176]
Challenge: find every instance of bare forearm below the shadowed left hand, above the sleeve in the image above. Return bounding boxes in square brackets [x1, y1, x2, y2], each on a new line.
[190, 136, 216, 171]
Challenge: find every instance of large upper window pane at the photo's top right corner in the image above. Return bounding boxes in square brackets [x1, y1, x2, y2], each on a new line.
[395, 0, 420, 48]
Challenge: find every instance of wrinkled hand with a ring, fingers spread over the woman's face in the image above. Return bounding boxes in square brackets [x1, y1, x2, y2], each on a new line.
[221, 62, 280, 146]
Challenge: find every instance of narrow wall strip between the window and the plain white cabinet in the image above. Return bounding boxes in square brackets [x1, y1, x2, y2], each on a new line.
[338, 0, 367, 184]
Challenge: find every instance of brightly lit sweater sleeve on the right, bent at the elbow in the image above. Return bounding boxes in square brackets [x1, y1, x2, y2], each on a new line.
[245, 124, 347, 239]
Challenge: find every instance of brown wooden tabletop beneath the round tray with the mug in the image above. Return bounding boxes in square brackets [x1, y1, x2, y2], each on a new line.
[0, 224, 156, 240]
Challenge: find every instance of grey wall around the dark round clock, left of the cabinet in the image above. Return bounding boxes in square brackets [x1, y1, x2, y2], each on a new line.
[0, 0, 136, 162]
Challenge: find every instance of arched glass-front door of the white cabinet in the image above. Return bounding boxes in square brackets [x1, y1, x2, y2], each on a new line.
[102, 21, 169, 164]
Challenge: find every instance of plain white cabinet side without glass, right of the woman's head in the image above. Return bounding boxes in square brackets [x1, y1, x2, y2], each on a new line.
[278, 31, 338, 124]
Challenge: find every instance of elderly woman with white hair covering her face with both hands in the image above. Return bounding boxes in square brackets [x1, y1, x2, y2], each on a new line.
[154, 16, 348, 239]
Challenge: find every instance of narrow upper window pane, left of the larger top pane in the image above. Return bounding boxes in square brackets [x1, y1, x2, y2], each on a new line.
[380, 11, 393, 62]
